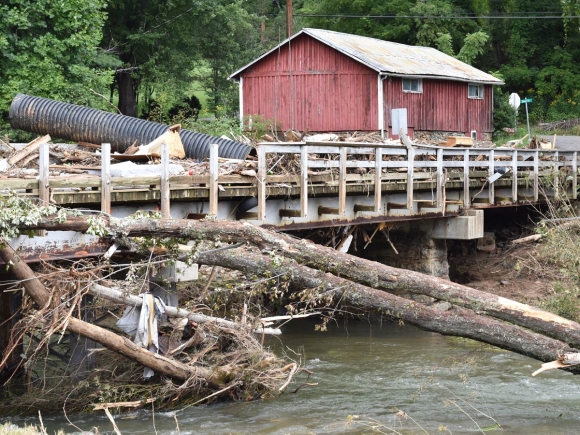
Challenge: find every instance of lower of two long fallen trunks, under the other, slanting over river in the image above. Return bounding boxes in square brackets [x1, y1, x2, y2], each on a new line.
[199, 247, 574, 361]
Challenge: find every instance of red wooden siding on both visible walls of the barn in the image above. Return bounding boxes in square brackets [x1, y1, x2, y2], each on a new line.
[241, 35, 493, 138]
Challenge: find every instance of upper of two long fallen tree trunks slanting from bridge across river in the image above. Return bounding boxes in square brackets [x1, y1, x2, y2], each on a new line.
[28, 217, 580, 347]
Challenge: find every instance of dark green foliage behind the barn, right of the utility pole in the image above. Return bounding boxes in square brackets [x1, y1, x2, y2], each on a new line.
[299, 0, 580, 124]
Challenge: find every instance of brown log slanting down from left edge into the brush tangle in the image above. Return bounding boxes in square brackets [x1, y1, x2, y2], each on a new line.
[0, 242, 221, 386]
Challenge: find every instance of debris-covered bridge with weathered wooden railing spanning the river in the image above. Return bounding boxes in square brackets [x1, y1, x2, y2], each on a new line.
[0, 137, 578, 262]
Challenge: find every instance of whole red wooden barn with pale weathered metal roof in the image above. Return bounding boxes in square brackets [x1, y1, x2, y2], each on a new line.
[230, 29, 503, 139]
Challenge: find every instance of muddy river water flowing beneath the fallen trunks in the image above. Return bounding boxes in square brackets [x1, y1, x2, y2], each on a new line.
[4, 321, 580, 435]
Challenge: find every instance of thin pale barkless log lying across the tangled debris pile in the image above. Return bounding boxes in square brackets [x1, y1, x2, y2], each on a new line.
[89, 284, 282, 335]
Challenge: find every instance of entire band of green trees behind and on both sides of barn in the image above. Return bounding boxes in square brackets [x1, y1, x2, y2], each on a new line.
[0, 0, 580, 131]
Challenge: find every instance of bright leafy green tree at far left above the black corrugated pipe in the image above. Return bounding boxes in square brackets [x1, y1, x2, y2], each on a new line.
[0, 0, 111, 128]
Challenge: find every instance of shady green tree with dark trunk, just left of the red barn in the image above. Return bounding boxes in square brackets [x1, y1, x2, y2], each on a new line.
[103, 0, 258, 116]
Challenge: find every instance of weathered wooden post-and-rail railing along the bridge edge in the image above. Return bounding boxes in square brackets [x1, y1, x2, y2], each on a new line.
[0, 142, 578, 221]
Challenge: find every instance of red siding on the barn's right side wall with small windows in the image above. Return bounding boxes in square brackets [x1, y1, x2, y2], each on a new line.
[383, 77, 493, 138]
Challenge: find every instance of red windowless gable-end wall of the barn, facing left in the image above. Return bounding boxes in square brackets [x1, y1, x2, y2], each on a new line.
[241, 35, 378, 131]
